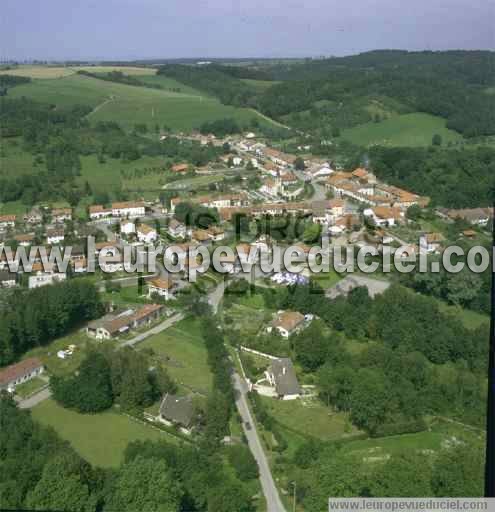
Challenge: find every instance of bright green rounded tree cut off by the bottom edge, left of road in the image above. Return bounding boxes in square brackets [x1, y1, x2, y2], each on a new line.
[108, 456, 183, 512]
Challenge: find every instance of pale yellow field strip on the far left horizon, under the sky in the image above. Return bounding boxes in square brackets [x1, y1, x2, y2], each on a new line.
[0, 66, 156, 79]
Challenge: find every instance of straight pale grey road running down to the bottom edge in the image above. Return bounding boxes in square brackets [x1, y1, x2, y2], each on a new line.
[234, 373, 285, 512]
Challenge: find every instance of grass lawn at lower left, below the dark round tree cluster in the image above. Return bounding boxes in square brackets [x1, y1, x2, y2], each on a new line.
[32, 399, 177, 467]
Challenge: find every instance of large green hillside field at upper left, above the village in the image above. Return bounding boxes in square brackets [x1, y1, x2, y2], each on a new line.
[9, 75, 274, 130]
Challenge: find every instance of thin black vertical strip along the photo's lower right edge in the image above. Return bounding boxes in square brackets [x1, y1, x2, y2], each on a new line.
[485, 204, 495, 498]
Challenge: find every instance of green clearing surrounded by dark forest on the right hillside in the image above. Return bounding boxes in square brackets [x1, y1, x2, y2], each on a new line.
[342, 112, 462, 146]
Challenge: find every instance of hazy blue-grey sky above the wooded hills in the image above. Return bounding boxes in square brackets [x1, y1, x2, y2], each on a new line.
[0, 0, 495, 59]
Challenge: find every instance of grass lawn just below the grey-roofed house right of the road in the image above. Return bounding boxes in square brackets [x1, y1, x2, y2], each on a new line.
[262, 397, 359, 441]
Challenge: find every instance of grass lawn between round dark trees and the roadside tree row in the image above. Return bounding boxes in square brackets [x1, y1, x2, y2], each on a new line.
[139, 318, 212, 394]
